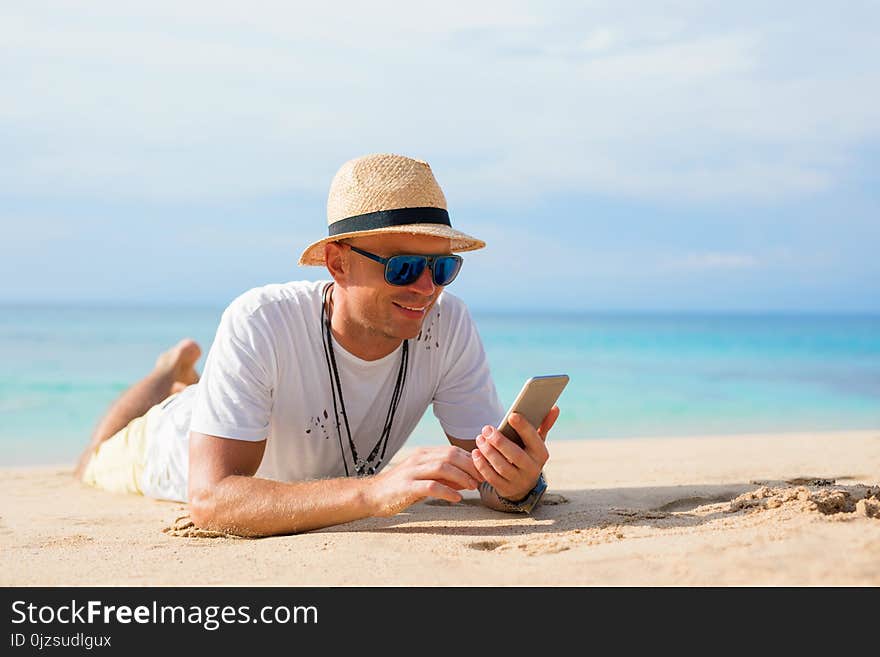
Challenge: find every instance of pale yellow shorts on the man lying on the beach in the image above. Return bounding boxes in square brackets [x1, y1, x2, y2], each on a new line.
[82, 404, 162, 495]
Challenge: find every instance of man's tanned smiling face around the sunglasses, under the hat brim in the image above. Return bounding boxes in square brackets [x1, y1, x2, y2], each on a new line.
[342, 233, 451, 340]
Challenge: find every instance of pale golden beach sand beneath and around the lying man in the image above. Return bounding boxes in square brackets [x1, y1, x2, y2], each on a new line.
[0, 430, 880, 586]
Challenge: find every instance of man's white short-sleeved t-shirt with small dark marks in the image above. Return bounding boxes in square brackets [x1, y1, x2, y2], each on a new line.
[141, 281, 504, 501]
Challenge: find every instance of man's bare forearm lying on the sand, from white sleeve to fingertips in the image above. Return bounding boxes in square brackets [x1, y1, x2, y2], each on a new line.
[189, 431, 482, 536]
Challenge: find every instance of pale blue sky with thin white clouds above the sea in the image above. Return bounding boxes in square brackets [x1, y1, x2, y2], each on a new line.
[0, 0, 880, 313]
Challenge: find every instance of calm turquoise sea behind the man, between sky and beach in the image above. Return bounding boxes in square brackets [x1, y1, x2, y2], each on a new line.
[0, 306, 880, 465]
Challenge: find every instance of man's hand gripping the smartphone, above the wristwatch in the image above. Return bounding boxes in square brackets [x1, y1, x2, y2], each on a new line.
[471, 406, 559, 500]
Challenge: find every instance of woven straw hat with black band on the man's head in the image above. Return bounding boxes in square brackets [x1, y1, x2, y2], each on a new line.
[299, 153, 486, 265]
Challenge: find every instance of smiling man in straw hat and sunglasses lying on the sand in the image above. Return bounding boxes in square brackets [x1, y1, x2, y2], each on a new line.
[77, 154, 559, 536]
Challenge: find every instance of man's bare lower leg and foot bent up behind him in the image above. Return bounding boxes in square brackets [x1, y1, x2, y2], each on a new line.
[74, 338, 202, 478]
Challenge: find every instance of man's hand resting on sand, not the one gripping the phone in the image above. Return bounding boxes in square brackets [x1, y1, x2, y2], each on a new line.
[367, 446, 484, 516]
